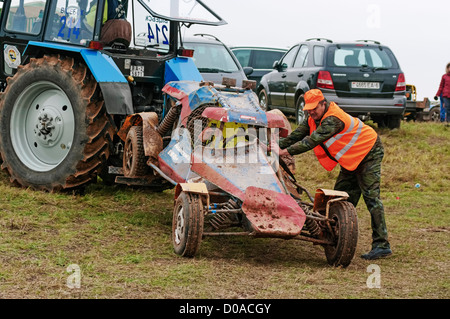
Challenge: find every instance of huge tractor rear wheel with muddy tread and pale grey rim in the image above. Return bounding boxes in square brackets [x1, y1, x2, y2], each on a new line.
[0, 55, 114, 191]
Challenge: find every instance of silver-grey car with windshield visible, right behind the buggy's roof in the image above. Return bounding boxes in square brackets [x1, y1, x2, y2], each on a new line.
[183, 34, 253, 86]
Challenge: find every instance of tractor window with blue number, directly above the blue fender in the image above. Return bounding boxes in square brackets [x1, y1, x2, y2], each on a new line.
[45, 0, 97, 45]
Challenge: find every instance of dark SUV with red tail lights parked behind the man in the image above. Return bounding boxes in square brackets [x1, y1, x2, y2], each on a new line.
[257, 39, 406, 128]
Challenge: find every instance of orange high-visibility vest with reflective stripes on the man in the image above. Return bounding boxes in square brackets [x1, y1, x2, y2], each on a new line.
[308, 102, 377, 171]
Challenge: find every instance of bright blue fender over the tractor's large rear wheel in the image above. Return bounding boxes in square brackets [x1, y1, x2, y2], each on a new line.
[24, 41, 127, 83]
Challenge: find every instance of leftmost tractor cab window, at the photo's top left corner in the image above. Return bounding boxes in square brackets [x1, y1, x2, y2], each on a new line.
[6, 0, 46, 34]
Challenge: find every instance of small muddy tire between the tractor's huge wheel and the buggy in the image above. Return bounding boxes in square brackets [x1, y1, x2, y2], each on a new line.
[123, 126, 148, 177]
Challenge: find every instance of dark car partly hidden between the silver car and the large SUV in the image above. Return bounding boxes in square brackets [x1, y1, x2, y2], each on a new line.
[230, 47, 287, 86]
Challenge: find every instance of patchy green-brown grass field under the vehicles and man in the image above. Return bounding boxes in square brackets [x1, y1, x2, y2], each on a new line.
[0, 122, 450, 299]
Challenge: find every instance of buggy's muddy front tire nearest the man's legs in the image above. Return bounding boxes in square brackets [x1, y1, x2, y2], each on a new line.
[324, 201, 358, 268]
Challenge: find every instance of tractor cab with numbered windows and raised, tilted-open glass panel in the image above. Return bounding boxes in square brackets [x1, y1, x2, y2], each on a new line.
[0, 0, 226, 76]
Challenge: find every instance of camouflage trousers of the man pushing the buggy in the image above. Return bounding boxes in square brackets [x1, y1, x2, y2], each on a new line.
[334, 138, 390, 249]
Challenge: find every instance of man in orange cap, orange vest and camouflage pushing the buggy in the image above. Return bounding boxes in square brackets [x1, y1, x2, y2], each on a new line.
[270, 89, 392, 260]
